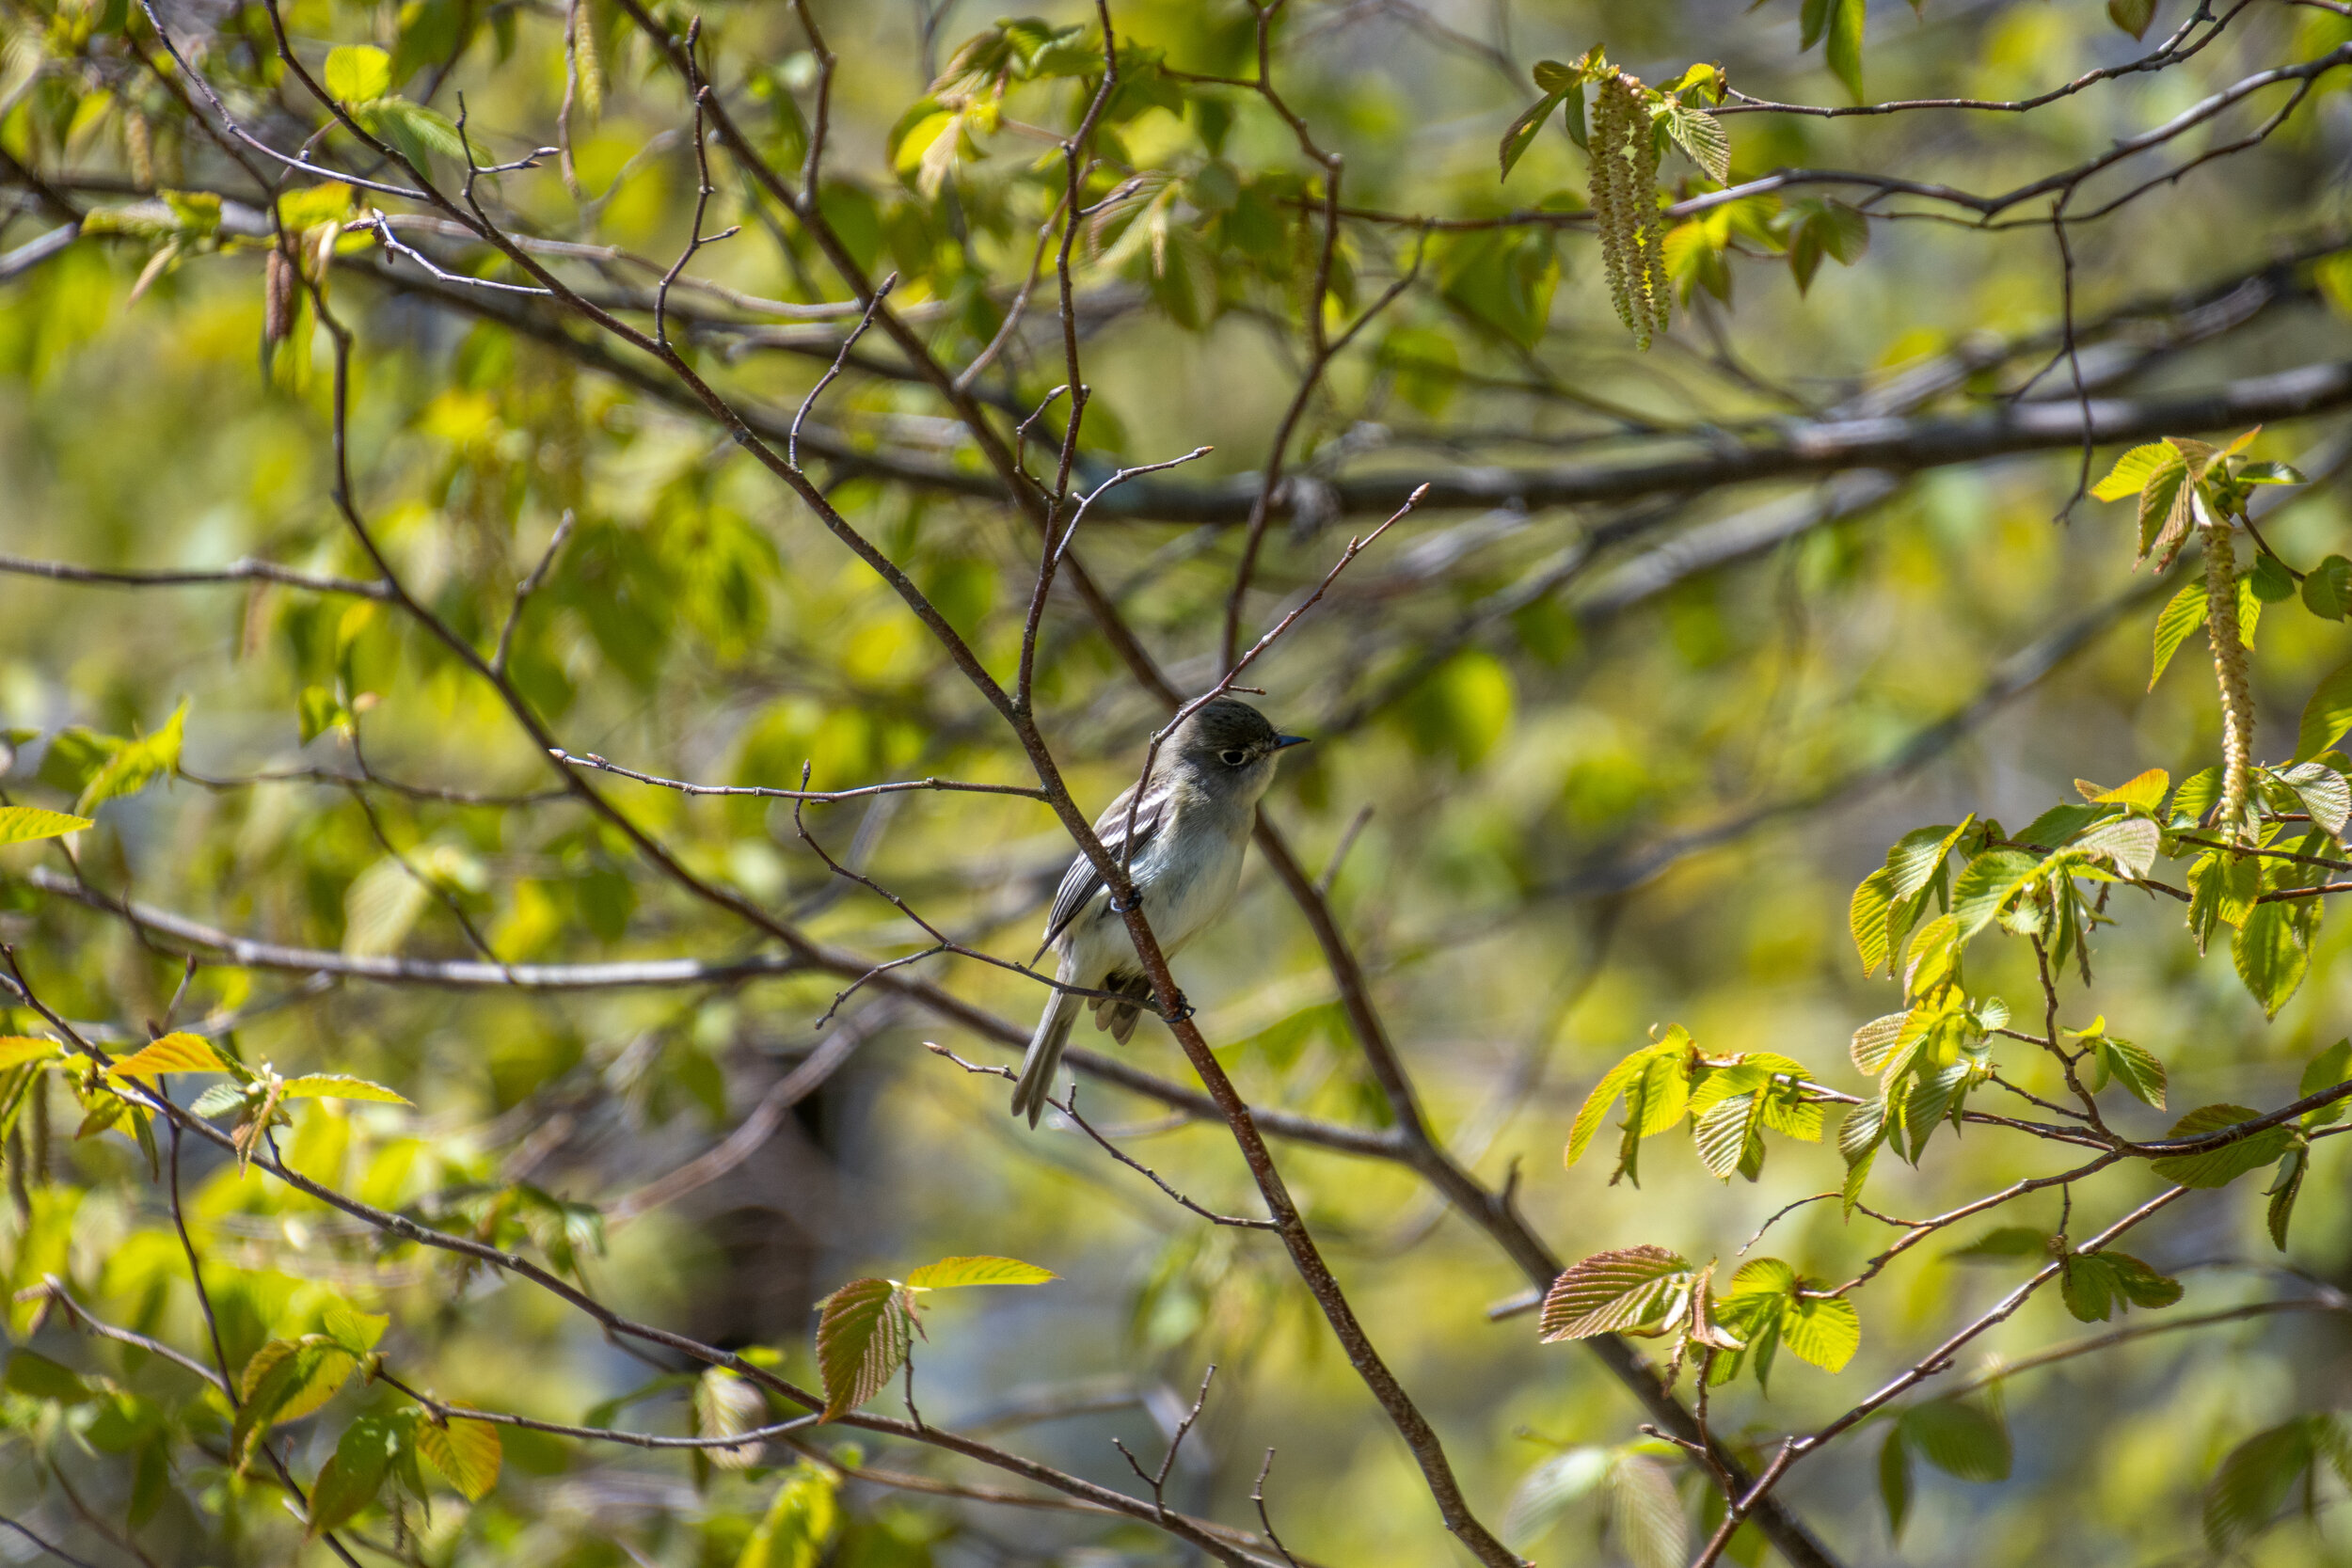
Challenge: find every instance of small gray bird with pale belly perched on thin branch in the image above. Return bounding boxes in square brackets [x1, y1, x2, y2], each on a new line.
[1014, 696, 1306, 1126]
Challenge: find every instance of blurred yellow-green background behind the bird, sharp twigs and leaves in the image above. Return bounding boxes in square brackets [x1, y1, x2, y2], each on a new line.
[0, 0, 2352, 1568]
